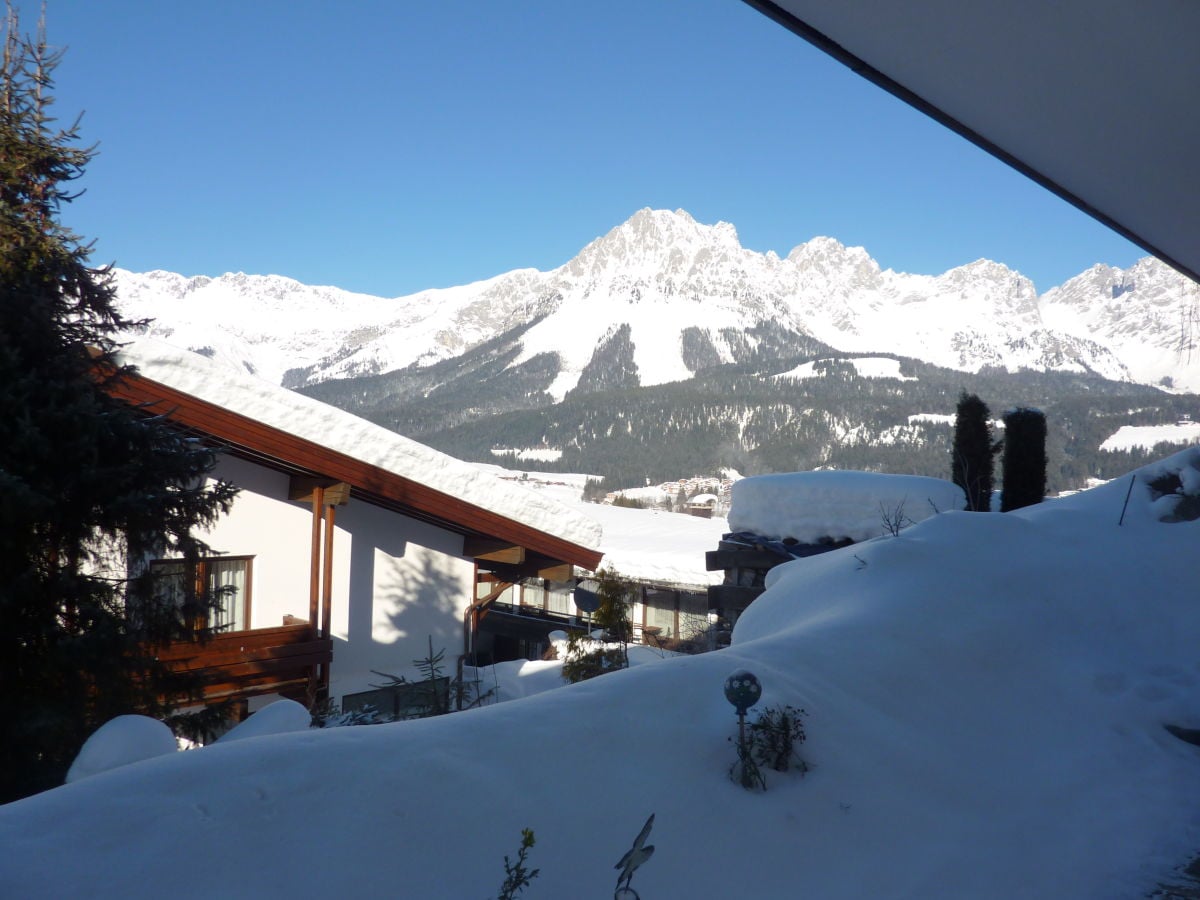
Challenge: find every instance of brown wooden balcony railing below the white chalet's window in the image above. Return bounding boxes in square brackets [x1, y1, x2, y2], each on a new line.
[156, 622, 334, 702]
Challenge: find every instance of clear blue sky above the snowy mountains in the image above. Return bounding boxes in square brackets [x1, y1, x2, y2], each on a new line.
[19, 0, 1145, 296]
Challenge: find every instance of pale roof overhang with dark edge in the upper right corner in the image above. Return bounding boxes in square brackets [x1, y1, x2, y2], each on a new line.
[744, 0, 1200, 281]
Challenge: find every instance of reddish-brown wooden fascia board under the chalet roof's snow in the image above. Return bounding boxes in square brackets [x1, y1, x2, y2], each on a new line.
[106, 373, 602, 570]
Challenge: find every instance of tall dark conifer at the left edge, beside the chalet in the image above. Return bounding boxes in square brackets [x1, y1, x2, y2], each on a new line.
[0, 7, 233, 803]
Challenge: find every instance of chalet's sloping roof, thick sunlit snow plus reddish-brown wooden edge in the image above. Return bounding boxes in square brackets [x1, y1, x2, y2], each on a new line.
[115, 340, 601, 569]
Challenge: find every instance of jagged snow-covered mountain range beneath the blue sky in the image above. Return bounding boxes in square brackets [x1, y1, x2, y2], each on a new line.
[116, 209, 1200, 398]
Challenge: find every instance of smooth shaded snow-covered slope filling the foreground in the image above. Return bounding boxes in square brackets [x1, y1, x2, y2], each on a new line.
[0, 448, 1200, 900]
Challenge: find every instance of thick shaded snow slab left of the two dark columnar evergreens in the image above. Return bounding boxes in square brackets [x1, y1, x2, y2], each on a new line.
[728, 470, 966, 544]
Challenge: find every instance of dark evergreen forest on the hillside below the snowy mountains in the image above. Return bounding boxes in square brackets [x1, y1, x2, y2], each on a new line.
[295, 323, 1200, 493]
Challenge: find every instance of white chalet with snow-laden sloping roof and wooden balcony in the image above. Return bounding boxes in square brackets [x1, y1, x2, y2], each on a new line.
[114, 341, 601, 710]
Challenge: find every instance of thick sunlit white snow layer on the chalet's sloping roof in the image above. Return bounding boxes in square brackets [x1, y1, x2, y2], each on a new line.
[112, 340, 600, 568]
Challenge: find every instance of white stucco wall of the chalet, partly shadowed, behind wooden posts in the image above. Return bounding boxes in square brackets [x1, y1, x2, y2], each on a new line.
[198, 456, 474, 701]
